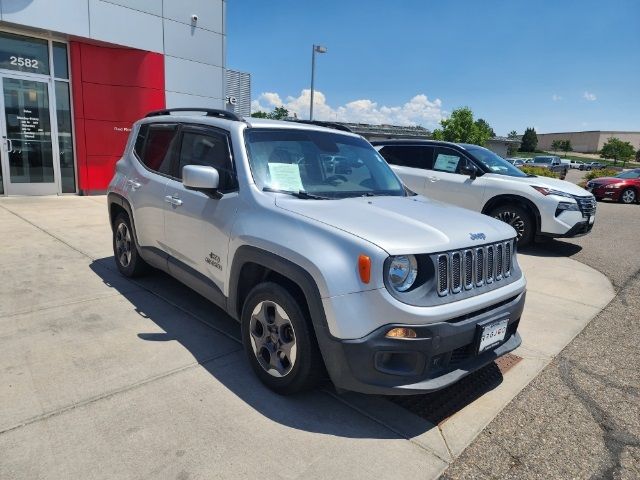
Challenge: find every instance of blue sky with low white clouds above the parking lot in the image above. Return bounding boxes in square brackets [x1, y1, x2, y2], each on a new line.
[227, 0, 640, 134]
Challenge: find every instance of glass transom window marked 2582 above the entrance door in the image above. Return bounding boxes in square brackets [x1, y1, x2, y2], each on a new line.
[0, 32, 49, 75]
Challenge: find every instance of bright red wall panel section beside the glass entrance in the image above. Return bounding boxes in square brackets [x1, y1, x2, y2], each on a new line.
[69, 41, 165, 193]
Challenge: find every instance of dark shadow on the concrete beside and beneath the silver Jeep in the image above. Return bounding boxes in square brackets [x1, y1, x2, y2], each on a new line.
[90, 257, 502, 439]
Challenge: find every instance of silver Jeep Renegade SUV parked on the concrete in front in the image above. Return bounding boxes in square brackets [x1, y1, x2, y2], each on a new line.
[108, 109, 526, 395]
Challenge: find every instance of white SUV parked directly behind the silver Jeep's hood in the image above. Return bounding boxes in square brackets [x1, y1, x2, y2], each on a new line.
[373, 140, 596, 245]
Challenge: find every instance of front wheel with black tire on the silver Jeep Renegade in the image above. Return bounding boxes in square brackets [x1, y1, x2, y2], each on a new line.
[241, 282, 325, 395]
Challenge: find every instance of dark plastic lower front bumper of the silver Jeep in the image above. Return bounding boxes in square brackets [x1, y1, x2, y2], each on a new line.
[320, 291, 525, 395]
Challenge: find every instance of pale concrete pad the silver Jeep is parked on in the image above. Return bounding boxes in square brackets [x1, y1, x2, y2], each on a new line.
[0, 197, 613, 479]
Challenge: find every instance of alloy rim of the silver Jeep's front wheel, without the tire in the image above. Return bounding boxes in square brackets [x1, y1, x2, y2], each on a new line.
[249, 300, 298, 377]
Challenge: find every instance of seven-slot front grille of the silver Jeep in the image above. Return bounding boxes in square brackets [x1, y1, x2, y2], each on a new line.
[432, 240, 513, 297]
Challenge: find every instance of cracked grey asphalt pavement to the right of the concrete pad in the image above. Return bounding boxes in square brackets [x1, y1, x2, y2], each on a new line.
[443, 173, 640, 480]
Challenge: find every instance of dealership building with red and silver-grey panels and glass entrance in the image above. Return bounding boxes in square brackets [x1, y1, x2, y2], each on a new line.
[0, 0, 229, 195]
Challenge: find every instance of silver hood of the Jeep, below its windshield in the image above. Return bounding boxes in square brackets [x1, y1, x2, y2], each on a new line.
[275, 195, 516, 255]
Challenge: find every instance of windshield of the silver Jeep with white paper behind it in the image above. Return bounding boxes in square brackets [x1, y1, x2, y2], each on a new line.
[245, 129, 406, 199]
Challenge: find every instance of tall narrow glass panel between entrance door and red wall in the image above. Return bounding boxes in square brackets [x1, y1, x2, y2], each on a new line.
[56, 81, 76, 193]
